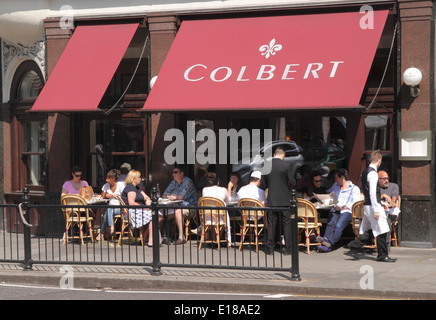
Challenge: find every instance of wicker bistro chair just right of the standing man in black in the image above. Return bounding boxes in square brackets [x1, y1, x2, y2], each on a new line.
[297, 198, 322, 254]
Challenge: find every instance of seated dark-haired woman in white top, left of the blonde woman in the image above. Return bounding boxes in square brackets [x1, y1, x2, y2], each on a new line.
[97, 169, 124, 241]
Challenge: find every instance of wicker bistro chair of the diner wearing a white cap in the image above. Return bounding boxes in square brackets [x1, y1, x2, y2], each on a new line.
[238, 198, 268, 252]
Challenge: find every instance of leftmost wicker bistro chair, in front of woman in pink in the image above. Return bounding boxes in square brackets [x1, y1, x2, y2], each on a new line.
[61, 194, 94, 245]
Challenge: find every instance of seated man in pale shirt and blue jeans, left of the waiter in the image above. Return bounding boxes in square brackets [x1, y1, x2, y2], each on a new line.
[316, 169, 360, 252]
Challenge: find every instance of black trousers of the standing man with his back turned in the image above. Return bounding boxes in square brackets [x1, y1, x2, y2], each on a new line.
[266, 211, 291, 251]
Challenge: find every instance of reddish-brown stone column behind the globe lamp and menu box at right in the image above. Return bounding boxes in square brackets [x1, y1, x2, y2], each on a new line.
[398, 0, 436, 247]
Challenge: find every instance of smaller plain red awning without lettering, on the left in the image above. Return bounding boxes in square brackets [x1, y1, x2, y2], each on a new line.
[32, 23, 138, 112]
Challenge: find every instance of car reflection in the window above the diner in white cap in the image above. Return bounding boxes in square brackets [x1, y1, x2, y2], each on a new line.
[232, 140, 304, 184]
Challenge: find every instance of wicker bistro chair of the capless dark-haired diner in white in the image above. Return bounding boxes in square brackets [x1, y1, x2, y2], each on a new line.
[198, 197, 227, 250]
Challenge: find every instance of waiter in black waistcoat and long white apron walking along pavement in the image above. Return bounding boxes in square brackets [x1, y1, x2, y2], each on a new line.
[348, 151, 397, 262]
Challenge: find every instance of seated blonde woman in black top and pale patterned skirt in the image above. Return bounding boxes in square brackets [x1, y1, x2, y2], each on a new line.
[121, 170, 162, 247]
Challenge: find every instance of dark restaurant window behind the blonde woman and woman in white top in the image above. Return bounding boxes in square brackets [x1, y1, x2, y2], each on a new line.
[88, 118, 147, 188]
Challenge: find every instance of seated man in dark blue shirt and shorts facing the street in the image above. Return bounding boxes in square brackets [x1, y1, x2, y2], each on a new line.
[162, 166, 197, 244]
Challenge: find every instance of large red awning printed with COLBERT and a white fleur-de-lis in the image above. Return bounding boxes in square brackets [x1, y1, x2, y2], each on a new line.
[143, 10, 388, 111]
